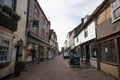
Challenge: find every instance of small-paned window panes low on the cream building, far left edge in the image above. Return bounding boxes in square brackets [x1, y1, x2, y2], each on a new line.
[0, 38, 10, 63]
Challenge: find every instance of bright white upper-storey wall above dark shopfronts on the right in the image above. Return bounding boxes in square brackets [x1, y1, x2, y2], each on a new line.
[75, 21, 96, 46]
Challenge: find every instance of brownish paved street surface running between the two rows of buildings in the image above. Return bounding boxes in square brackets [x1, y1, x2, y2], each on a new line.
[4, 56, 114, 80]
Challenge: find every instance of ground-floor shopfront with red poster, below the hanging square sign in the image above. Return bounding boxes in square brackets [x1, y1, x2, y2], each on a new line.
[26, 32, 49, 62]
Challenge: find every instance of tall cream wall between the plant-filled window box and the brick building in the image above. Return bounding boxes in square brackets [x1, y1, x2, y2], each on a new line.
[14, 0, 28, 60]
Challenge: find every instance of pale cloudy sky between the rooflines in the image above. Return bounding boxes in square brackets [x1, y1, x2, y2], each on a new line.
[38, 0, 103, 49]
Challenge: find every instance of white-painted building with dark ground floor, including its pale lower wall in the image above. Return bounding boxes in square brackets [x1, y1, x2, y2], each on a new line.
[75, 16, 97, 68]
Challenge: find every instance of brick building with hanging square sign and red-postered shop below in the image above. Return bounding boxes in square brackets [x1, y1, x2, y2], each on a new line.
[26, 0, 50, 61]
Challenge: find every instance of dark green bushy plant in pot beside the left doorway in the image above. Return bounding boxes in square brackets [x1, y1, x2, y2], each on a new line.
[15, 61, 25, 77]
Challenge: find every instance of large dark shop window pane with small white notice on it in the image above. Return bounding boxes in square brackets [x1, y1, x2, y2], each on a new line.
[101, 40, 116, 63]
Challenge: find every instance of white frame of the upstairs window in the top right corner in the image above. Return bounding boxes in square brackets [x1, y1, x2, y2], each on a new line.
[111, 0, 120, 23]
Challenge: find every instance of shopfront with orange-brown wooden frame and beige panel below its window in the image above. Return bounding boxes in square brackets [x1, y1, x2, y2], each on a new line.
[99, 35, 120, 78]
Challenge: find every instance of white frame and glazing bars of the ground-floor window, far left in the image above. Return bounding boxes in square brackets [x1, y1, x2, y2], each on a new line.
[0, 37, 11, 64]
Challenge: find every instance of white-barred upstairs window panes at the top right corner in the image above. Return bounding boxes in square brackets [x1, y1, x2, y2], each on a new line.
[112, 0, 120, 22]
